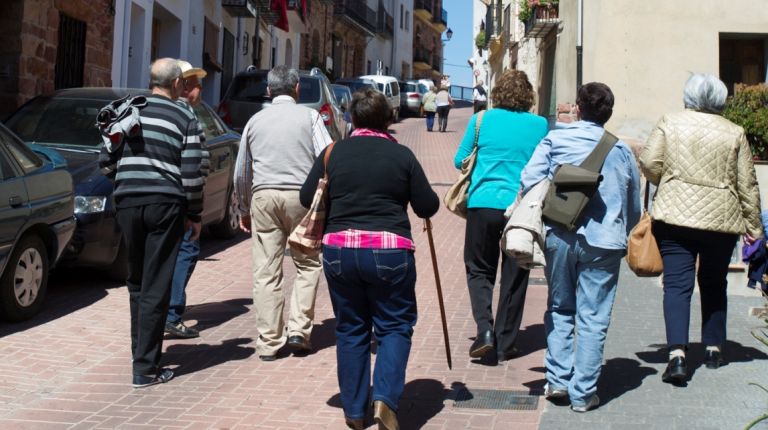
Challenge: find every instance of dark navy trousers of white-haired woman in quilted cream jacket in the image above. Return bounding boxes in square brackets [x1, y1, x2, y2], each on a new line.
[653, 221, 738, 346]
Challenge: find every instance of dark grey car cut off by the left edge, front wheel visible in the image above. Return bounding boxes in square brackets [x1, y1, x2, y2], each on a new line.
[0, 125, 75, 321]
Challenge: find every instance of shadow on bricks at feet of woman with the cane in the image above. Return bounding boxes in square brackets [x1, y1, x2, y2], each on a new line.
[326, 379, 450, 429]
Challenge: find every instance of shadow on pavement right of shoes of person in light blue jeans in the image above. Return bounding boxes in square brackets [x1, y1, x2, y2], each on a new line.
[597, 357, 658, 405]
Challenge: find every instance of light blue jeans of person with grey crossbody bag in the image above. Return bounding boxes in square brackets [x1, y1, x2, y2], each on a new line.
[544, 229, 624, 406]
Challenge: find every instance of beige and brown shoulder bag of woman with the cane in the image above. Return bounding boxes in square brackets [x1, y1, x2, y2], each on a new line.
[288, 142, 336, 254]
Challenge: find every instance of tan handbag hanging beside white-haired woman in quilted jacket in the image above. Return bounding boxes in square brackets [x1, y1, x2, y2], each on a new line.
[626, 184, 664, 276]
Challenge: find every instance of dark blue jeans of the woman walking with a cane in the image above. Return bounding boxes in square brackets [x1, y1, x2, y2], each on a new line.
[323, 245, 416, 419]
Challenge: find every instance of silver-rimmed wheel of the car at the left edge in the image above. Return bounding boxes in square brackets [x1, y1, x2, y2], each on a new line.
[0, 235, 48, 321]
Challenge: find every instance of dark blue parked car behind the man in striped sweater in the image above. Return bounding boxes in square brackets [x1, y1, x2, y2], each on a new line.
[6, 88, 240, 280]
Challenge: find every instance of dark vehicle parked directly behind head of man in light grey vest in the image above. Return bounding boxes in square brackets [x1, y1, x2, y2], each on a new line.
[217, 68, 347, 141]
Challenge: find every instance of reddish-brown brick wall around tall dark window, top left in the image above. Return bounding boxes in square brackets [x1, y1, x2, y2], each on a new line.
[0, 0, 114, 115]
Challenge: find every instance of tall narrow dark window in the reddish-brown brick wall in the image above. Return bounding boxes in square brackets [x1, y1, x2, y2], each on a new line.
[54, 13, 86, 90]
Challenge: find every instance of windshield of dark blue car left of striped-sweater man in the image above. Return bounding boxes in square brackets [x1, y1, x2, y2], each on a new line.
[5, 97, 108, 148]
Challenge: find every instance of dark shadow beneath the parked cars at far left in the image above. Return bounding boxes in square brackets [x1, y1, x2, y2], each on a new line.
[0, 268, 119, 338]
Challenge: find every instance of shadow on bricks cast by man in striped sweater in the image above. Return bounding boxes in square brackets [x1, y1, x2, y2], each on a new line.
[163, 337, 256, 376]
